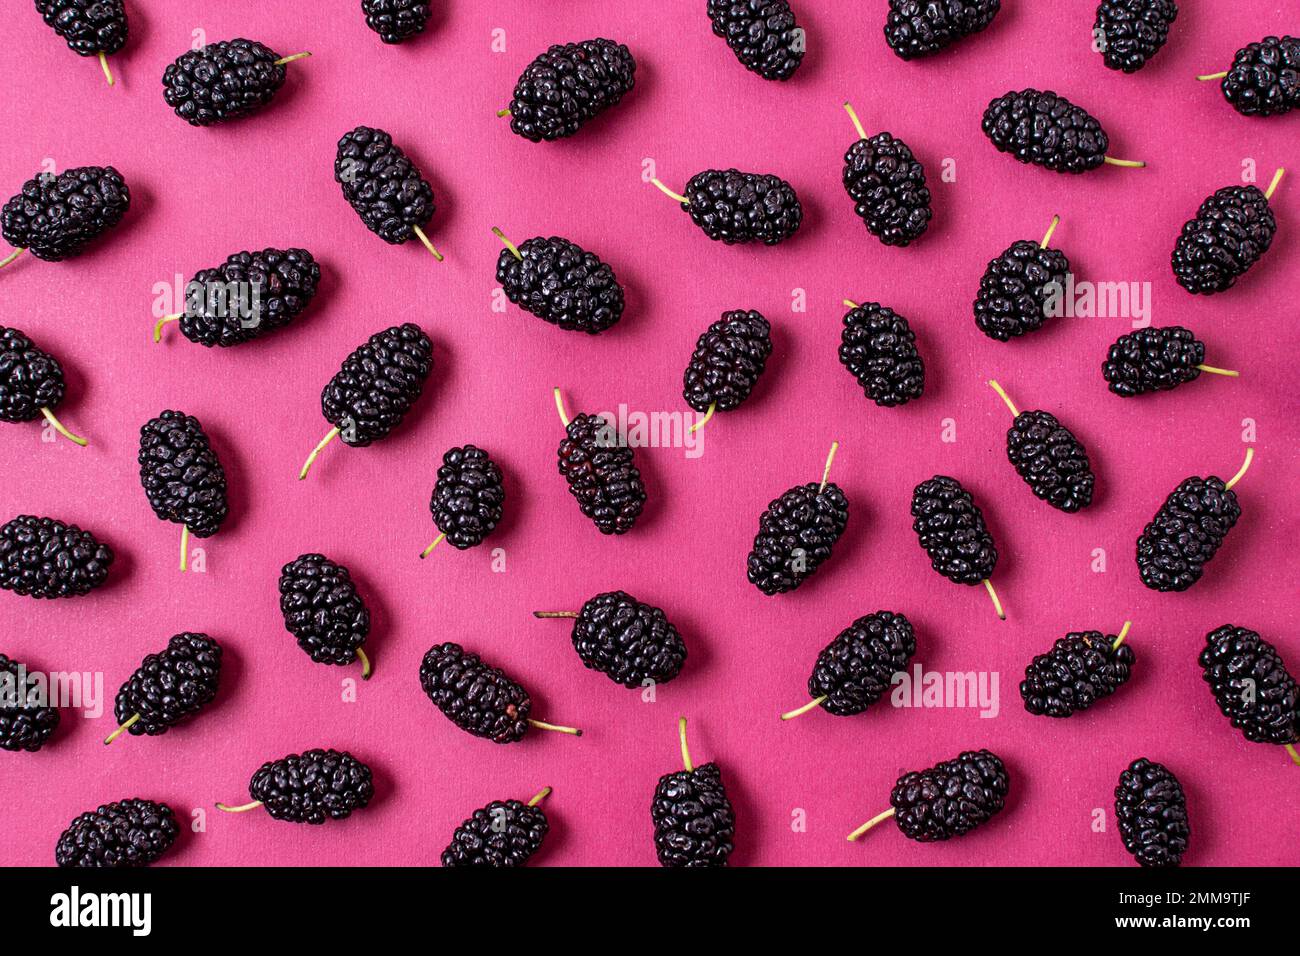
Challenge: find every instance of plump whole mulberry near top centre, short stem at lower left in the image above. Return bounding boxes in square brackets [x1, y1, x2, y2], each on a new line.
[501, 38, 637, 143]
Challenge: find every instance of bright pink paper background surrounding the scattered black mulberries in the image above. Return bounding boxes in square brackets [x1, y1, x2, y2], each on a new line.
[0, 0, 1300, 865]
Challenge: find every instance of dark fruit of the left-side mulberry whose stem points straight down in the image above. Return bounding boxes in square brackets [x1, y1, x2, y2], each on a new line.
[139, 411, 230, 546]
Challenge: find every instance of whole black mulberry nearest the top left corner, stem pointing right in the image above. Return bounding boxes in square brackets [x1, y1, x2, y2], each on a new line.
[163, 39, 311, 126]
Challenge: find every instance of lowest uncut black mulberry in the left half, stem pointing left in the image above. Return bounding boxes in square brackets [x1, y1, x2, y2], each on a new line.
[217, 749, 374, 825]
